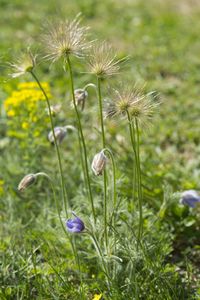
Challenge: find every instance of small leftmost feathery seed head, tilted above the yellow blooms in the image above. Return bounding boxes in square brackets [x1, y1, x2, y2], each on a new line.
[9, 49, 37, 78]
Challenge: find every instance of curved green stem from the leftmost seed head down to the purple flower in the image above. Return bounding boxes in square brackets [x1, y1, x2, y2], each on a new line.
[30, 71, 67, 216]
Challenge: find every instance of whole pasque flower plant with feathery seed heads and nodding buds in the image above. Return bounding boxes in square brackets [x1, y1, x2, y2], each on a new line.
[7, 12, 189, 299]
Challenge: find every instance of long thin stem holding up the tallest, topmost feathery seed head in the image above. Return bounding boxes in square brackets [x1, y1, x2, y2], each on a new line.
[67, 56, 96, 222]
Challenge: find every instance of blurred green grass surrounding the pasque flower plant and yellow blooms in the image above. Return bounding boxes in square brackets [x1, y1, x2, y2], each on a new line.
[0, 0, 200, 299]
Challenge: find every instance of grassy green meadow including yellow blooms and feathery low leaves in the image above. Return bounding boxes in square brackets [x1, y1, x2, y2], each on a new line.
[0, 0, 200, 300]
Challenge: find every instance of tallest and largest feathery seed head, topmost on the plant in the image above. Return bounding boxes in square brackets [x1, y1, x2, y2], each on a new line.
[43, 15, 90, 62]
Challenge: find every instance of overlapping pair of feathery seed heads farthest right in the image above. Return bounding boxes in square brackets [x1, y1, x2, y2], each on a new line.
[106, 86, 159, 124]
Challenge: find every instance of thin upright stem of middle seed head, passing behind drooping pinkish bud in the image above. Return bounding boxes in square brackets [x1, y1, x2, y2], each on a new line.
[97, 77, 108, 247]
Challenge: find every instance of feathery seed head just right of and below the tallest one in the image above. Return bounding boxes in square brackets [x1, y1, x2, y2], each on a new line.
[89, 42, 124, 78]
